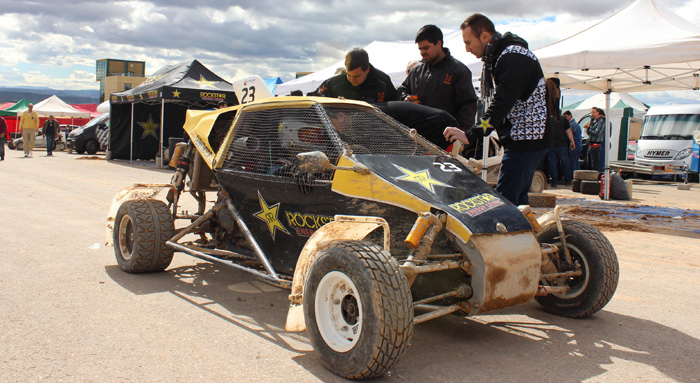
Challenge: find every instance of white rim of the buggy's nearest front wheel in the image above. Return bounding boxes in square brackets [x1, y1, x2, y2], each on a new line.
[314, 271, 364, 352]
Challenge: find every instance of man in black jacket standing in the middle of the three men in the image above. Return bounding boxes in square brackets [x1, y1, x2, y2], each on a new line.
[398, 25, 477, 130]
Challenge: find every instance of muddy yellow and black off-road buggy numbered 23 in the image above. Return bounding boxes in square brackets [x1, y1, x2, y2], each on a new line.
[108, 97, 619, 378]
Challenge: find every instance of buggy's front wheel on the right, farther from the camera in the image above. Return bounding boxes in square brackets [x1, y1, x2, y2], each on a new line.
[535, 221, 620, 318]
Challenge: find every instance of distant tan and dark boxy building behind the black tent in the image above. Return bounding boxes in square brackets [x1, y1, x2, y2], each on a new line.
[95, 59, 146, 102]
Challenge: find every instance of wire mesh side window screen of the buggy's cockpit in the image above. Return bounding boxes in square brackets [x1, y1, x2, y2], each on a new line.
[223, 103, 340, 184]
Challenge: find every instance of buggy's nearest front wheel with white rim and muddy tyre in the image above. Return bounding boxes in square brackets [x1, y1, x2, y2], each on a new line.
[304, 241, 413, 379]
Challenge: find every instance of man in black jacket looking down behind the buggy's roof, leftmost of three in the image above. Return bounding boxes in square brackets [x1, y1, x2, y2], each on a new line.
[315, 48, 397, 103]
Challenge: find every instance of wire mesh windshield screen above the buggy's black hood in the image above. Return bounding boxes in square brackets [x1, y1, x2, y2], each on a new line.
[323, 104, 441, 155]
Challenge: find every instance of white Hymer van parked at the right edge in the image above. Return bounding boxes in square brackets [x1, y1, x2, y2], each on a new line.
[634, 104, 700, 178]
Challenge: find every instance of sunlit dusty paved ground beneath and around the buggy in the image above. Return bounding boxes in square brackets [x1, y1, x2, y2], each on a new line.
[0, 151, 700, 382]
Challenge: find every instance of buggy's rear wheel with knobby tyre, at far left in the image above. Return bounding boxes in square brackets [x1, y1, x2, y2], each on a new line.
[113, 200, 175, 273]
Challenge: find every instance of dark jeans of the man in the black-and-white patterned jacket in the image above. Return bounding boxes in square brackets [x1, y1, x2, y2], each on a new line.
[496, 149, 549, 206]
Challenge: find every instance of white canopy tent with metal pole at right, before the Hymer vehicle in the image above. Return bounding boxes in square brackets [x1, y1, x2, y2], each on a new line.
[535, 0, 700, 199]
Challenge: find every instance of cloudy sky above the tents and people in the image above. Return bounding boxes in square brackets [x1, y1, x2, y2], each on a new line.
[0, 0, 700, 102]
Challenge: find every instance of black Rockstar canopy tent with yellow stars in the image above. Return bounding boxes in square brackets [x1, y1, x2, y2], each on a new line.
[109, 60, 238, 160]
